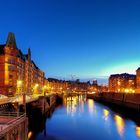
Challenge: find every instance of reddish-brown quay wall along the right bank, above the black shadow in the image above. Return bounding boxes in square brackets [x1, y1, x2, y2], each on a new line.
[87, 92, 140, 111]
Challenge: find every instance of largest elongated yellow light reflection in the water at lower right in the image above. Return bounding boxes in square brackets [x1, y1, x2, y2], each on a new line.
[114, 115, 125, 136]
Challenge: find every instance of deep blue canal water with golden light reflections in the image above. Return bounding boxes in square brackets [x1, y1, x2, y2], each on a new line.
[36, 96, 140, 140]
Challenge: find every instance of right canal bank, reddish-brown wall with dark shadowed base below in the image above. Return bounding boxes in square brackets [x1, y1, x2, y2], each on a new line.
[87, 93, 140, 126]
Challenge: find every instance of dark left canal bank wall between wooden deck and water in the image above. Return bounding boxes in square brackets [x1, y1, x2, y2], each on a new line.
[26, 95, 62, 140]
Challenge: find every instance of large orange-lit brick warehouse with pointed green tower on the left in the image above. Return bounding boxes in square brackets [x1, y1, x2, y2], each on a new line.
[0, 32, 45, 95]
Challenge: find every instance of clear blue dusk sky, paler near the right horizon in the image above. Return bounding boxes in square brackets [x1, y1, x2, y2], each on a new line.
[0, 0, 140, 83]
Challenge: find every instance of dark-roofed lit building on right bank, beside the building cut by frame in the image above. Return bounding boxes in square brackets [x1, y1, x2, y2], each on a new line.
[109, 73, 136, 93]
